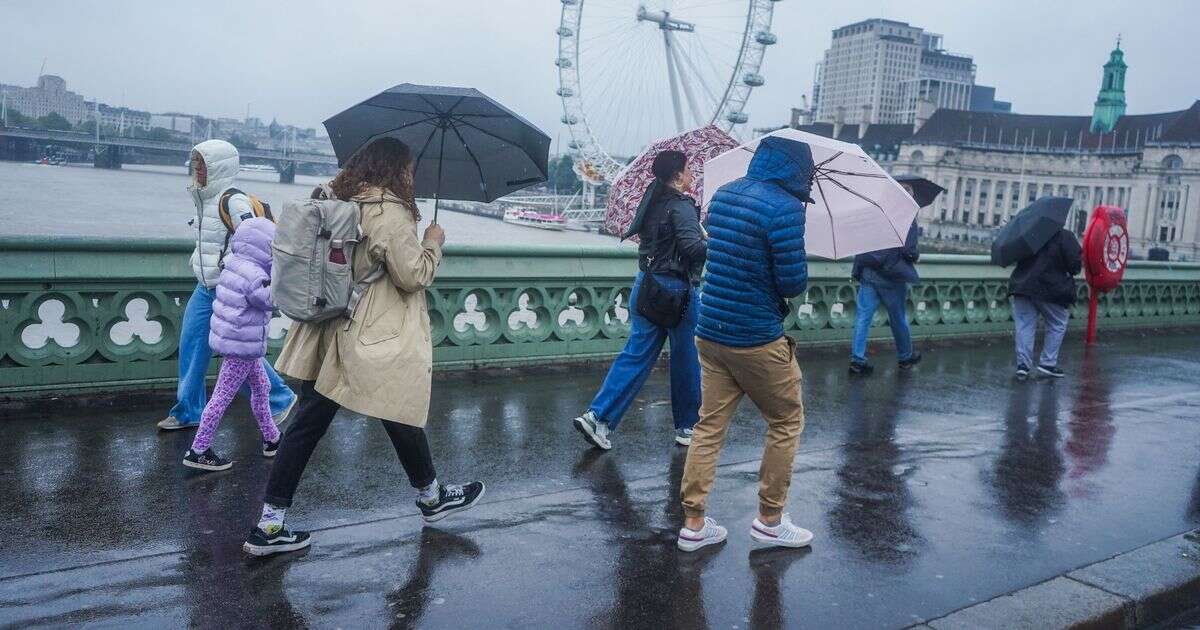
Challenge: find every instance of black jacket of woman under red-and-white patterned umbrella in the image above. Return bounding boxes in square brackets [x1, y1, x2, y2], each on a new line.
[625, 182, 708, 284]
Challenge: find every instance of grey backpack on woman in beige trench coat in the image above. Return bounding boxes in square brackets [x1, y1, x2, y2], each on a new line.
[271, 185, 384, 325]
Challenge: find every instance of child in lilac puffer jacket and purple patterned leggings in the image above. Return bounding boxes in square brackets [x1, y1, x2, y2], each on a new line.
[184, 218, 280, 470]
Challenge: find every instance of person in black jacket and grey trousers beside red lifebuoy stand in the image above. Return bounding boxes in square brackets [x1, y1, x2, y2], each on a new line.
[1008, 224, 1084, 380]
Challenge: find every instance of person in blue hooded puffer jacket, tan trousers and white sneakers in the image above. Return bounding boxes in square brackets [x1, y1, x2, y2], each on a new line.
[677, 137, 814, 551]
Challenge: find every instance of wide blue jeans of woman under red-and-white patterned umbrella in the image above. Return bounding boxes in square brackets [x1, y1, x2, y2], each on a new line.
[590, 274, 700, 428]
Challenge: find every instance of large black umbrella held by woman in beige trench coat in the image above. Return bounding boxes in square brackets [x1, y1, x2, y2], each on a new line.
[325, 83, 550, 222]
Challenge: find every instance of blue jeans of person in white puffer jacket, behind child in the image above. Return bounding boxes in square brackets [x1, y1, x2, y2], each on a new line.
[170, 284, 295, 425]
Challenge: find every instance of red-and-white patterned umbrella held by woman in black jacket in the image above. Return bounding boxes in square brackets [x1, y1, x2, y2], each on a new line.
[604, 125, 738, 239]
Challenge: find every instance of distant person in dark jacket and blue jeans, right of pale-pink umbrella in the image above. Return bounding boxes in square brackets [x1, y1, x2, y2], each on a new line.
[850, 213, 920, 376]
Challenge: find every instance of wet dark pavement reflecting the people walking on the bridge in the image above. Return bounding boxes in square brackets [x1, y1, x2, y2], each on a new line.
[0, 331, 1200, 629]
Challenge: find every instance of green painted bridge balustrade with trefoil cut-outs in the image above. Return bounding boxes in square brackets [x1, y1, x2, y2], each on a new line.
[0, 236, 1200, 396]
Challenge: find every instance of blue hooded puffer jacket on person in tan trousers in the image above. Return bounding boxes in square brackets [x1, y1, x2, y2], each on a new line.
[696, 137, 812, 348]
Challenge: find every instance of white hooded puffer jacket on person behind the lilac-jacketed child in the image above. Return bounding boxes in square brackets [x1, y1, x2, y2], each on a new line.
[187, 140, 254, 289]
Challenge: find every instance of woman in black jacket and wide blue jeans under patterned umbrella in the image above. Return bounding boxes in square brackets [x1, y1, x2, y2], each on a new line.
[572, 151, 707, 450]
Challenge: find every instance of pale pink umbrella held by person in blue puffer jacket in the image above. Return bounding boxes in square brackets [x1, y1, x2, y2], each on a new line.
[703, 128, 919, 259]
